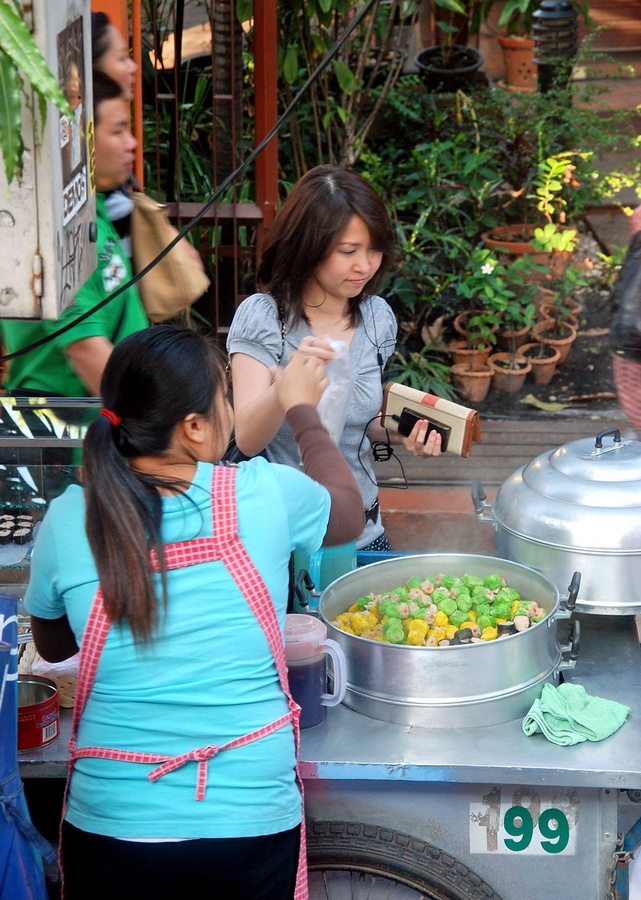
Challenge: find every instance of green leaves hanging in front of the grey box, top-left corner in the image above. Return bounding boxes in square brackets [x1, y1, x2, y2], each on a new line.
[0, 0, 73, 184]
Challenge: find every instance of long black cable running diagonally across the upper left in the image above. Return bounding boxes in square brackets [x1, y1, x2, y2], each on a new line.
[0, 0, 378, 363]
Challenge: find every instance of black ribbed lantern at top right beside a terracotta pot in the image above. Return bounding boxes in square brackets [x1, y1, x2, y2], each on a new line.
[532, 0, 579, 92]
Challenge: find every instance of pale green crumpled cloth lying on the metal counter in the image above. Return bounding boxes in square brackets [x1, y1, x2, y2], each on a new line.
[523, 683, 630, 747]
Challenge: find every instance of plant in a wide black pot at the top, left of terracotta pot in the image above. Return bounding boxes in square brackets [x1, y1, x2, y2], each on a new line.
[414, 0, 483, 92]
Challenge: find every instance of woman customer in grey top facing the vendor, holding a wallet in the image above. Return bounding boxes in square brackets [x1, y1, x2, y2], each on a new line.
[227, 166, 441, 550]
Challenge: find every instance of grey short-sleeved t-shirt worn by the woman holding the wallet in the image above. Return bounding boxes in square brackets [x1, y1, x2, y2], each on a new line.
[227, 294, 397, 547]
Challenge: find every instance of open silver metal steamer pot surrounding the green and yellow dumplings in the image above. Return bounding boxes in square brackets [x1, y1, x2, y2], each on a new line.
[319, 553, 579, 728]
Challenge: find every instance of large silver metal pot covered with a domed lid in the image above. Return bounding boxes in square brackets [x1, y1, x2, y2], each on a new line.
[472, 428, 641, 615]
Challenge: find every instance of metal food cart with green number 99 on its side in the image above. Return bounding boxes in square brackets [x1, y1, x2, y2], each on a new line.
[7, 410, 641, 900]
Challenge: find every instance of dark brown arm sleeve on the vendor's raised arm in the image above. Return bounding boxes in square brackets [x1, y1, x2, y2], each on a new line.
[286, 406, 365, 547]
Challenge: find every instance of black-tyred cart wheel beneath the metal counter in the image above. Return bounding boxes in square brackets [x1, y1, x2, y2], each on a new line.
[307, 822, 501, 900]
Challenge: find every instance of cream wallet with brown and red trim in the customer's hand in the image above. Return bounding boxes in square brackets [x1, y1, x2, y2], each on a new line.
[381, 381, 481, 457]
